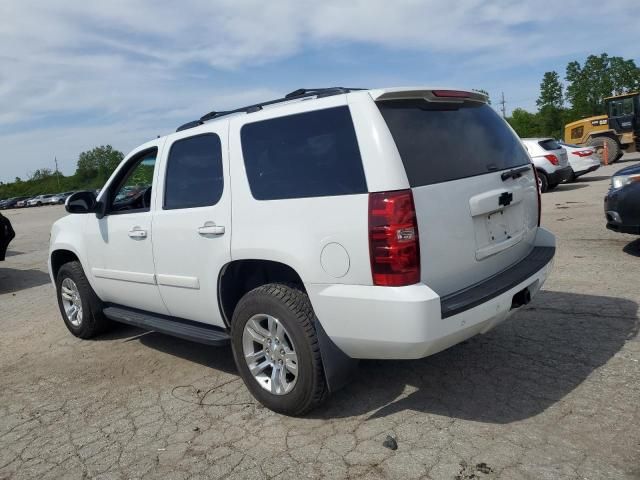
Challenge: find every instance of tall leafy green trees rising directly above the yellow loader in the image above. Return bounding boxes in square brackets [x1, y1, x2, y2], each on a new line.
[565, 53, 640, 117]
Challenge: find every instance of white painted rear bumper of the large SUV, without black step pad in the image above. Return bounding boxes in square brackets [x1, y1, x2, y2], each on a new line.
[306, 228, 555, 359]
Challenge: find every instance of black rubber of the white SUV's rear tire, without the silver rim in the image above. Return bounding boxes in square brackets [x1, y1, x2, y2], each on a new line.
[231, 283, 328, 416]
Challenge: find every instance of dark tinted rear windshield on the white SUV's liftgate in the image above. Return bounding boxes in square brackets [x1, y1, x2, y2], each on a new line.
[378, 100, 530, 187]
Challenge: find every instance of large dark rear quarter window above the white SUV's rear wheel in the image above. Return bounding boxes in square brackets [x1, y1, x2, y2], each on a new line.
[240, 106, 367, 200]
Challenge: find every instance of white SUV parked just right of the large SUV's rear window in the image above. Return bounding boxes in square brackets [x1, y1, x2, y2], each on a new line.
[522, 138, 573, 193]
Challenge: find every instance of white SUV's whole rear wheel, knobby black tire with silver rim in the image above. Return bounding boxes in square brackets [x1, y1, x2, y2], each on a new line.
[231, 283, 328, 416]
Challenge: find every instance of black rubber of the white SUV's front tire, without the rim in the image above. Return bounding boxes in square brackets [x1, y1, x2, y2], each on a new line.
[56, 261, 110, 339]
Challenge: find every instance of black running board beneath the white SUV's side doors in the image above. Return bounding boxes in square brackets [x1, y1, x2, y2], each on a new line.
[104, 306, 229, 346]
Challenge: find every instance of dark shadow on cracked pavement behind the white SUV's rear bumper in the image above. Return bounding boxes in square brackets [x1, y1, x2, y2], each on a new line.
[310, 291, 639, 424]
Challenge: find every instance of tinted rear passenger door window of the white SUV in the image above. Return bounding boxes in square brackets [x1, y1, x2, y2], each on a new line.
[164, 133, 224, 210]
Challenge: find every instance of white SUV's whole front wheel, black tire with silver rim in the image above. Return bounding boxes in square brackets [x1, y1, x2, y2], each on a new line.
[56, 261, 109, 339]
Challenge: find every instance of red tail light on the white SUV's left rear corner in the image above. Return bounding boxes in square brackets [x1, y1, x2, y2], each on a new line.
[369, 190, 420, 287]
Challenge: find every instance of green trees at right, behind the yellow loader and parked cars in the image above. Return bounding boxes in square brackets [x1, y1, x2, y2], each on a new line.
[507, 53, 640, 138]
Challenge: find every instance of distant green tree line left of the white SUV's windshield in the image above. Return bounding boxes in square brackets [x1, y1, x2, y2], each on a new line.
[0, 145, 124, 199]
